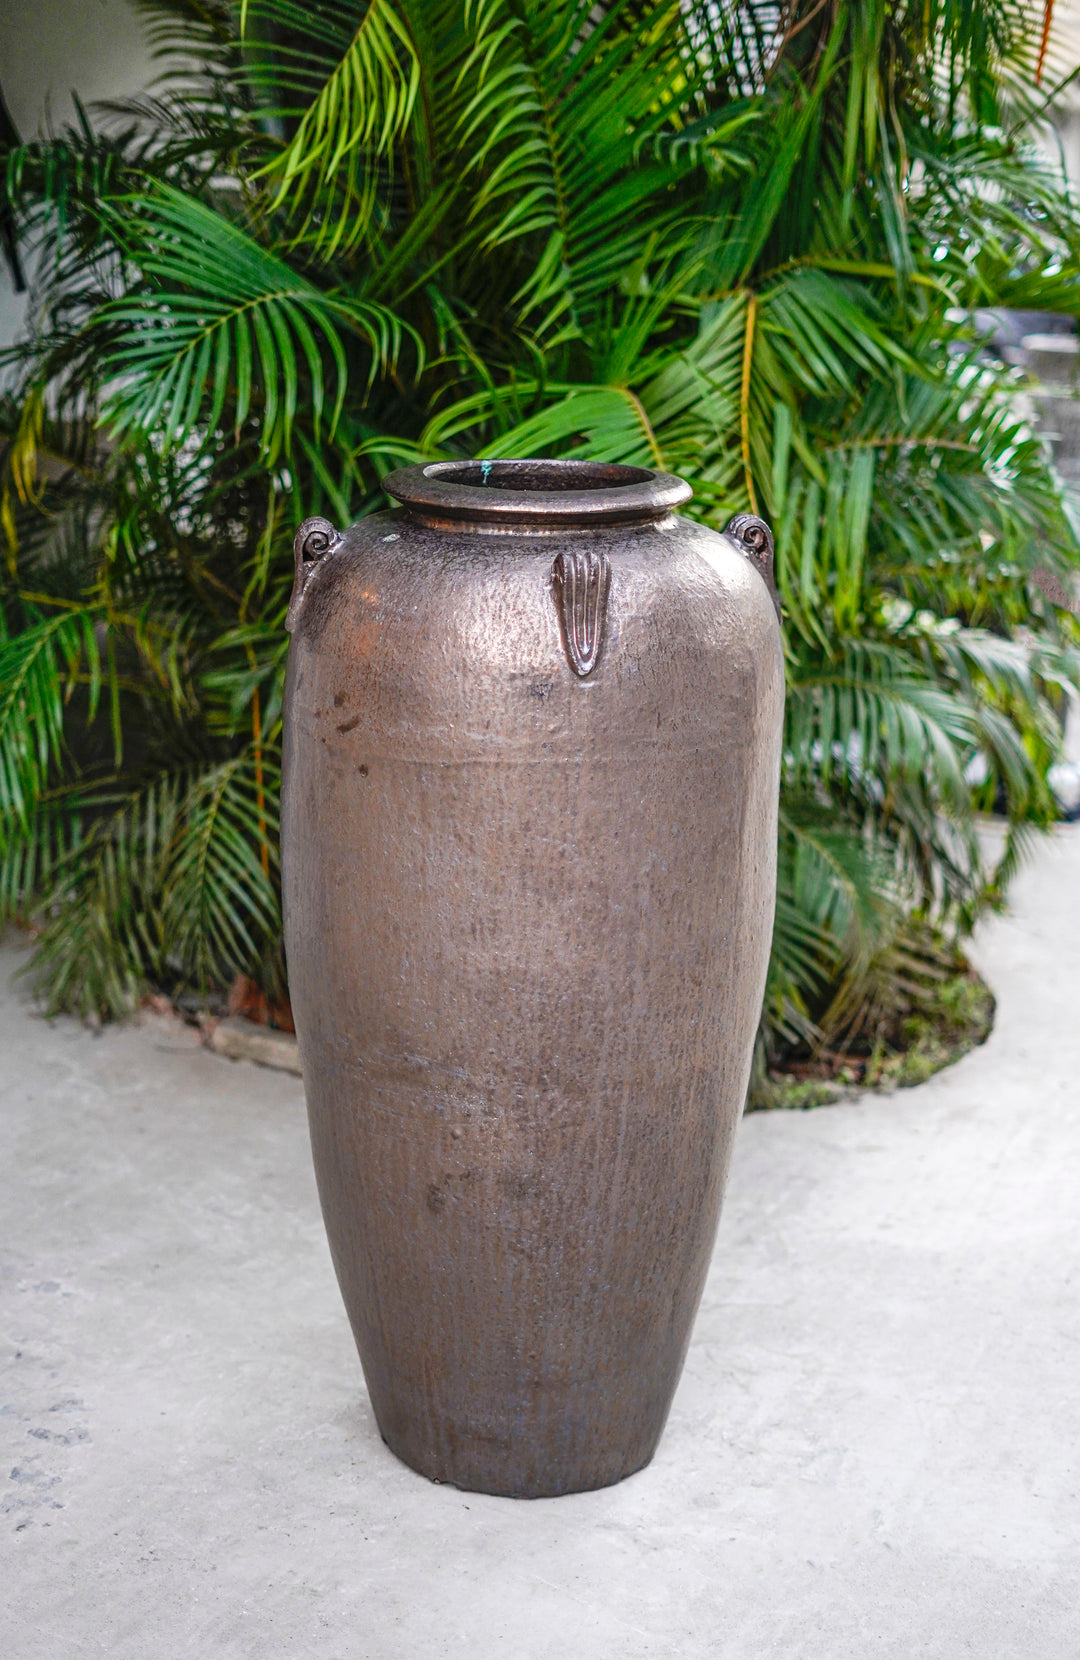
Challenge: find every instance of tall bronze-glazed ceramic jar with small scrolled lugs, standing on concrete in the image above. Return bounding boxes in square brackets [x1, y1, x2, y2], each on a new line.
[282, 461, 783, 1497]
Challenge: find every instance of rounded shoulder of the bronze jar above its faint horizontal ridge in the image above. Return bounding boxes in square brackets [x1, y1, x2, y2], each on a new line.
[287, 513, 783, 765]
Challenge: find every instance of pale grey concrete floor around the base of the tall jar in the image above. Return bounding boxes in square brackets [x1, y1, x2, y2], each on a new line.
[0, 827, 1080, 1660]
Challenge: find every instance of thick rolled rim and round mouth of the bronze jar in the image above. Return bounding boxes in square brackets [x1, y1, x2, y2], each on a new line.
[383, 460, 693, 530]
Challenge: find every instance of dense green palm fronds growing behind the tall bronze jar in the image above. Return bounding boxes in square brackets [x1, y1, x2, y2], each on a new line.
[0, 0, 1080, 1075]
